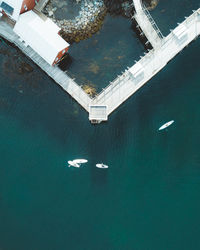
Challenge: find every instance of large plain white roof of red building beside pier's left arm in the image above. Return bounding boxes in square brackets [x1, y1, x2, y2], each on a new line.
[14, 10, 69, 65]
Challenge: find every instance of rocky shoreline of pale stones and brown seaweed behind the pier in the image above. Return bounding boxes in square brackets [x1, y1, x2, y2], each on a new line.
[43, 0, 159, 43]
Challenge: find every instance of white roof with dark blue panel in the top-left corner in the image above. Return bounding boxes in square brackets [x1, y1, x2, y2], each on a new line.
[0, 0, 23, 21]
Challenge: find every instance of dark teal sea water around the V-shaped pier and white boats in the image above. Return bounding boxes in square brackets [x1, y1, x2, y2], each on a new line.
[0, 0, 200, 250]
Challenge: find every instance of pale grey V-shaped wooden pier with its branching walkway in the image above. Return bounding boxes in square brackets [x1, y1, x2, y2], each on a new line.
[0, 0, 200, 123]
